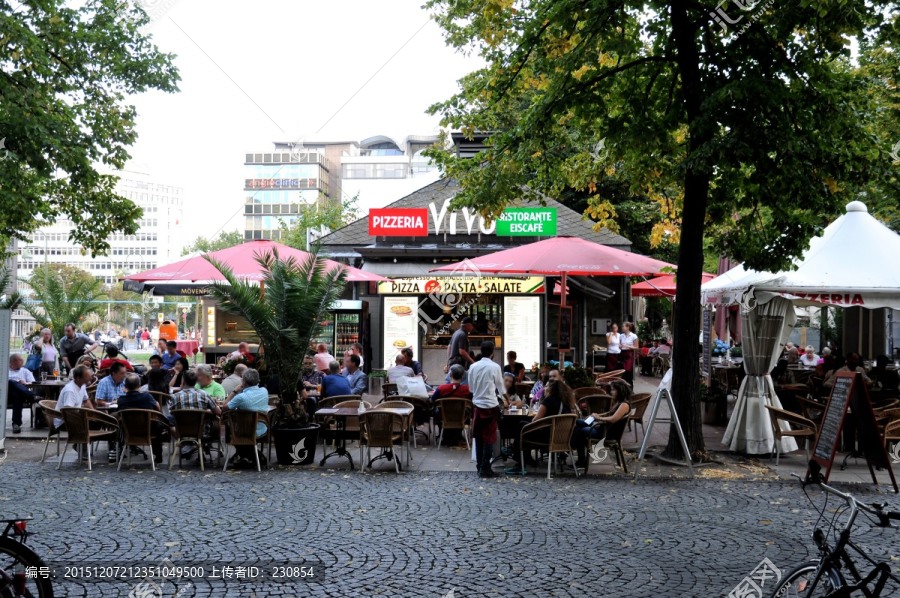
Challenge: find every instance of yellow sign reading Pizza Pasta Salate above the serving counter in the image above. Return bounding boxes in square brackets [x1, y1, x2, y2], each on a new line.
[378, 276, 544, 295]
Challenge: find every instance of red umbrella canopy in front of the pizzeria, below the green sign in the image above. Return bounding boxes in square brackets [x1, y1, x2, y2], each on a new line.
[432, 237, 672, 276]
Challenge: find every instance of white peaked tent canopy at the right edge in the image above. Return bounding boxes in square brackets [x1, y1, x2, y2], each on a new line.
[702, 201, 900, 309]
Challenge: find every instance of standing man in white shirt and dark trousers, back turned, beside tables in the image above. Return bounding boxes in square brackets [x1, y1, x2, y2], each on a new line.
[469, 341, 506, 478]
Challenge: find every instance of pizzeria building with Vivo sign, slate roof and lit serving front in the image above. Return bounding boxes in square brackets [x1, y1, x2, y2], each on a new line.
[321, 179, 631, 380]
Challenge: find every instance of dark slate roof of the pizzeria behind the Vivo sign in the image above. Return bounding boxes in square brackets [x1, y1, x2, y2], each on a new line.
[320, 178, 631, 254]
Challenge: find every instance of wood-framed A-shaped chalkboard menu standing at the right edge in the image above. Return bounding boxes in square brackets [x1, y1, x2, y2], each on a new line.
[813, 372, 900, 492]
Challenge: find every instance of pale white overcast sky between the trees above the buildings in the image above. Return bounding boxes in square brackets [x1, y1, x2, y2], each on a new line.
[125, 0, 479, 243]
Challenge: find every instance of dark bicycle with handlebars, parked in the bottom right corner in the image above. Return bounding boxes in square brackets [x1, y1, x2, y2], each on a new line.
[772, 462, 900, 598]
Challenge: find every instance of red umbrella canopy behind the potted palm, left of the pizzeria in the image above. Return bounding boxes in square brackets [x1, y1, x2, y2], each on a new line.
[125, 240, 387, 295]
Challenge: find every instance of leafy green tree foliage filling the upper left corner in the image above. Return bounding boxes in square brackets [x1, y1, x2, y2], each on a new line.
[0, 0, 178, 254]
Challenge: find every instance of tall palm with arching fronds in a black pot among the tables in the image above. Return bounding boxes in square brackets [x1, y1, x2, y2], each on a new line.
[206, 250, 346, 465]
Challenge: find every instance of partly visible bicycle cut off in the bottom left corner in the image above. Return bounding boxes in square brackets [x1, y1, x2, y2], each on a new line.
[0, 517, 53, 598]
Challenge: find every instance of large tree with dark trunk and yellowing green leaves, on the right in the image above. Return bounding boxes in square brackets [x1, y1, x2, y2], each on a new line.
[426, 0, 900, 456]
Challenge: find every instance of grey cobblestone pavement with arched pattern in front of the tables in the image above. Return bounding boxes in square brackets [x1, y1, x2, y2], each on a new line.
[0, 462, 900, 598]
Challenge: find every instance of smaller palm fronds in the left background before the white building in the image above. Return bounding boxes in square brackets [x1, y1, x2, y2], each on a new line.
[23, 264, 106, 339]
